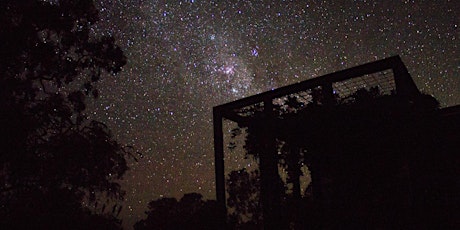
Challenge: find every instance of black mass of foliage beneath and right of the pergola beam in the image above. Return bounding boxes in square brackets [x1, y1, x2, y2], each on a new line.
[232, 88, 460, 229]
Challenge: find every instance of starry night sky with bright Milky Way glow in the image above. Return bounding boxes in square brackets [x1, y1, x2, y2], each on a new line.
[88, 0, 460, 227]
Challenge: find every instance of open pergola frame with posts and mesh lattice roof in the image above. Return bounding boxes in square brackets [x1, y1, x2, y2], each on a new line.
[213, 56, 420, 229]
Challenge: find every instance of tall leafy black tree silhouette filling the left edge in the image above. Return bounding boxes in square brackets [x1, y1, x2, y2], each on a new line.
[0, 0, 132, 229]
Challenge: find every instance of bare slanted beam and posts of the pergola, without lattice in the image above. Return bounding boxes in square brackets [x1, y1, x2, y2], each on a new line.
[213, 56, 420, 229]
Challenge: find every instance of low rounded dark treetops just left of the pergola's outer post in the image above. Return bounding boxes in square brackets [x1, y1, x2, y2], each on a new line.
[134, 193, 222, 230]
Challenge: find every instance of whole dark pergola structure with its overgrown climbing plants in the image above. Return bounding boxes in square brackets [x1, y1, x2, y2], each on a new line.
[213, 56, 460, 229]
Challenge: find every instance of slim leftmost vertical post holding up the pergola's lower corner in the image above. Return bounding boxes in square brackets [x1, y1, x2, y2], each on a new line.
[213, 107, 227, 229]
